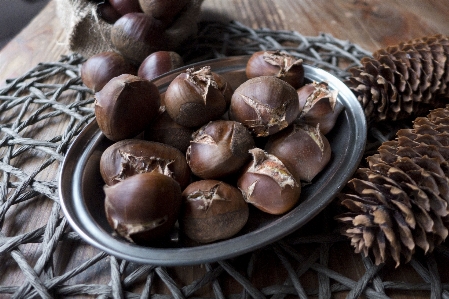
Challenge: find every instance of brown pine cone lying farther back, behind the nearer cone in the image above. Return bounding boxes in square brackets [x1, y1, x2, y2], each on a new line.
[345, 35, 449, 122]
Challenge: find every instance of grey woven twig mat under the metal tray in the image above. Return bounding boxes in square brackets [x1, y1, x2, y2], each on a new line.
[0, 22, 449, 299]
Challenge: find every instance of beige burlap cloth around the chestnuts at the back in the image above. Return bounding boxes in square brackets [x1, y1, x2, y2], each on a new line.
[55, 0, 203, 58]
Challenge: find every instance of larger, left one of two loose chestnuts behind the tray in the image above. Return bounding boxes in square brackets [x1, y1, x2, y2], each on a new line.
[81, 51, 137, 92]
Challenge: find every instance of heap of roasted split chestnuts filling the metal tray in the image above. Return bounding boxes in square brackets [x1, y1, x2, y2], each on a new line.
[83, 51, 343, 246]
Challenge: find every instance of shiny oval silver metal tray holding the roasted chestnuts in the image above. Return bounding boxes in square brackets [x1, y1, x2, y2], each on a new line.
[59, 56, 366, 266]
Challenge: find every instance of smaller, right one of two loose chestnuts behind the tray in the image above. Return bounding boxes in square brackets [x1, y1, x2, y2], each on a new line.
[137, 51, 184, 80]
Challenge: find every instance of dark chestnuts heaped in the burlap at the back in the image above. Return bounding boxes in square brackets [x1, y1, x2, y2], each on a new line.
[91, 0, 202, 64]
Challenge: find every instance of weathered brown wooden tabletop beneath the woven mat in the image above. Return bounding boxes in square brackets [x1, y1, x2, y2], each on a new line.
[0, 0, 449, 298]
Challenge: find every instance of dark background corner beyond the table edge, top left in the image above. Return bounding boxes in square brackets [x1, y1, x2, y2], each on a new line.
[0, 0, 51, 49]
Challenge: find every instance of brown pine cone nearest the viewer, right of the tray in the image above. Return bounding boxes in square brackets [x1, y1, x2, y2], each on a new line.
[337, 105, 449, 266]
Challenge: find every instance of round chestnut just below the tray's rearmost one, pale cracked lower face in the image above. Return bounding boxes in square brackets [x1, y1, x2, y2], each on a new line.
[229, 76, 300, 137]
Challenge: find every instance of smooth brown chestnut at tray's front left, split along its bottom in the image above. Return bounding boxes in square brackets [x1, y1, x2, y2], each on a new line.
[104, 172, 182, 245]
